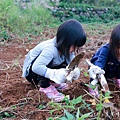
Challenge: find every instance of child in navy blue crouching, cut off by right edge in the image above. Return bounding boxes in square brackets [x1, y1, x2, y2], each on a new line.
[88, 24, 120, 96]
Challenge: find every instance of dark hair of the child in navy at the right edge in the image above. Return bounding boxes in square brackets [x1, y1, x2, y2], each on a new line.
[109, 24, 120, 58]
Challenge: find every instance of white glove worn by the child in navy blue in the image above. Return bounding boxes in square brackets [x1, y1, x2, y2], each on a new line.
[88, 65, 105, 79]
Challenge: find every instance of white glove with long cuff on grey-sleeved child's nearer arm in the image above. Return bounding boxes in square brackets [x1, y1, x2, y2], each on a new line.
[45, 68, 68, 84]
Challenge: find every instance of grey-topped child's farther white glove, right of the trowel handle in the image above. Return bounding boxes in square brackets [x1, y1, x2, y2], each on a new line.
[66, 67, 80, 82]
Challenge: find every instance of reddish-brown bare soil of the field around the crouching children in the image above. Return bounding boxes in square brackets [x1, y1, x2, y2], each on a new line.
[0, 29, 120, 120]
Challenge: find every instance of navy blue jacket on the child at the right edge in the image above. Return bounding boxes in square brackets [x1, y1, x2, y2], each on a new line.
[91, 44, 120, 79]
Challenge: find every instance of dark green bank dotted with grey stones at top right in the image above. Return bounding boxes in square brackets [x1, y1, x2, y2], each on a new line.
[52, 0, 120, 23]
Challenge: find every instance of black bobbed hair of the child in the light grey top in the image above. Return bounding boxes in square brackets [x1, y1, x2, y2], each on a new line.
[56, 19, 86, 59]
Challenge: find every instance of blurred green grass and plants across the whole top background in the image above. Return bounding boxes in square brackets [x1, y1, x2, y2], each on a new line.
[0, 0, 120, 40]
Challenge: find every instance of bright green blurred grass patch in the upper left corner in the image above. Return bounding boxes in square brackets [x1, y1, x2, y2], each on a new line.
[0, 0, 59, 39]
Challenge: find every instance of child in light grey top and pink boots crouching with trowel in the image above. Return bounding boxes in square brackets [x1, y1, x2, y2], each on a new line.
[22, 19, 86, 102]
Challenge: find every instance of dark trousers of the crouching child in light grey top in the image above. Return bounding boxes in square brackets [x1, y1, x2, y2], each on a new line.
[26, 62, 67, 88]
